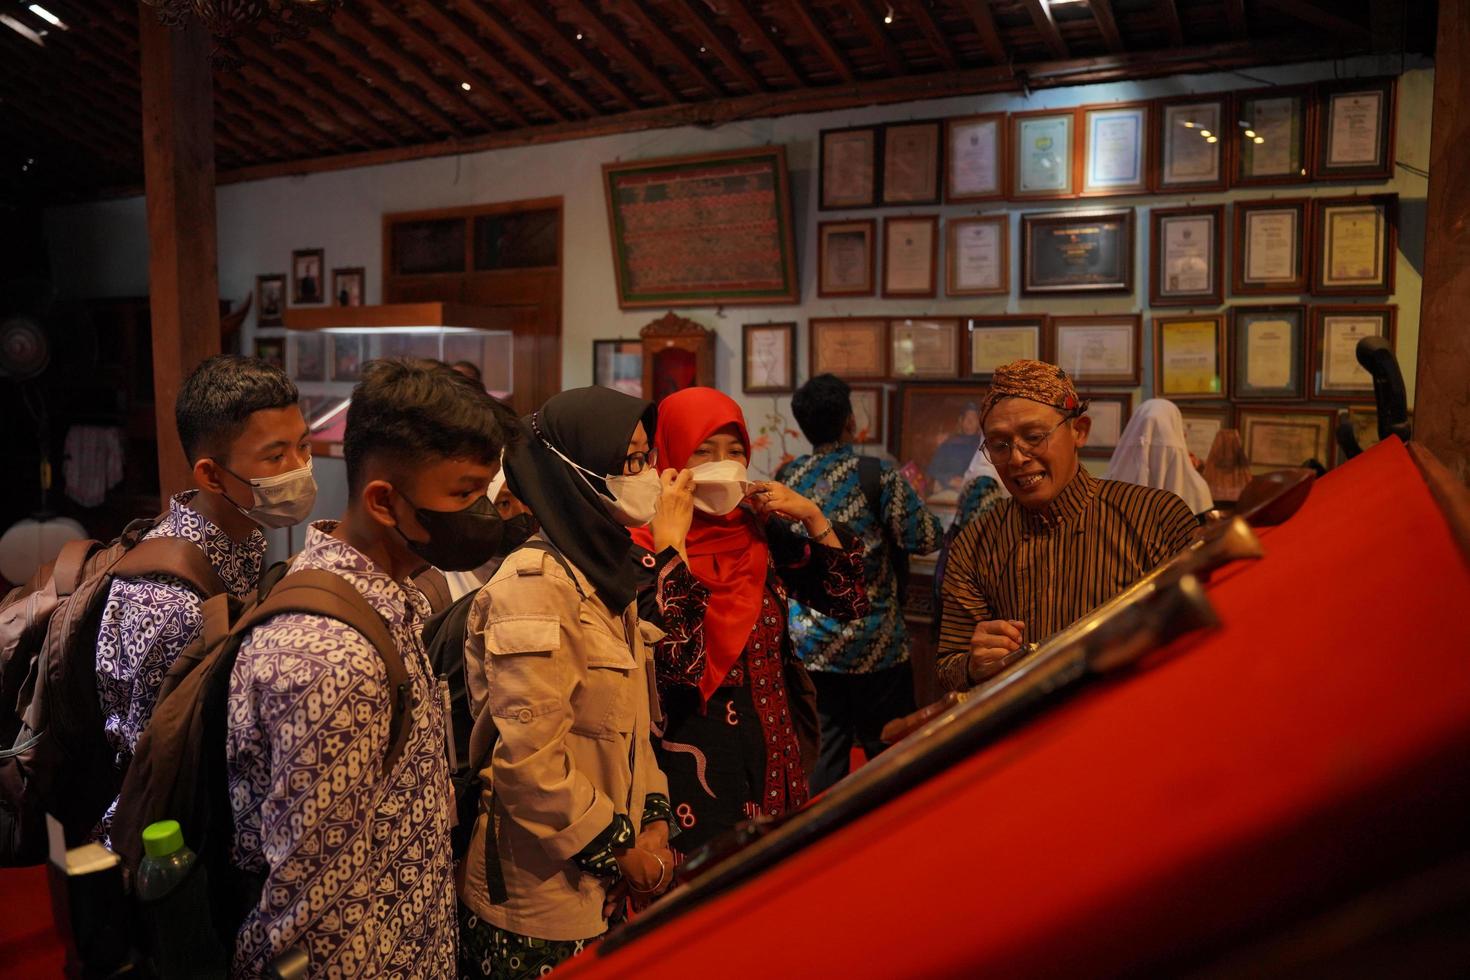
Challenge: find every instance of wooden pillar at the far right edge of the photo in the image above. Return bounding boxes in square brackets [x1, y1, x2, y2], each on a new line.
[1414, 0, 1470, 482]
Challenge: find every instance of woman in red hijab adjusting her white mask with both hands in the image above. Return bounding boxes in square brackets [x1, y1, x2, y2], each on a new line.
[635, 388, 867, 854]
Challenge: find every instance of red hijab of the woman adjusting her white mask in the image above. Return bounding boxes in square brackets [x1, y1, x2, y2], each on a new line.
[634, 388, 770, 701]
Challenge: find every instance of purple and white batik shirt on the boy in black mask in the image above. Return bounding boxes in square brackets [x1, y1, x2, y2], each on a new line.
[225, 522, 456, 979]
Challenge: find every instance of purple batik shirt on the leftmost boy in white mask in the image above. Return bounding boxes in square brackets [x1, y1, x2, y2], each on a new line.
[97, 491, 266, 842]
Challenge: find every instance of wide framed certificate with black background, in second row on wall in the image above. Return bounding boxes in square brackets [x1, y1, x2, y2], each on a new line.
[1020, 207, 1133, 294]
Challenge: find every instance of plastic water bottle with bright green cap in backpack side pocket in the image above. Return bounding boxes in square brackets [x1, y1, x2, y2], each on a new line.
[137, 820, 225, 980]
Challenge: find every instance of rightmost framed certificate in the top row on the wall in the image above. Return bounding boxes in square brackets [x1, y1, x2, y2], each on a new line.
[1311, 78, 1397, 181]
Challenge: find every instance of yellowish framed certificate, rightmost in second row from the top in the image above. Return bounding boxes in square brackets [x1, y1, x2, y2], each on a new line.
[1311, 194, 1398, 295]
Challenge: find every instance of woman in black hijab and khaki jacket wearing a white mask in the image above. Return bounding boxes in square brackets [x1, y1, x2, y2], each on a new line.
[459, 388, 673, 979]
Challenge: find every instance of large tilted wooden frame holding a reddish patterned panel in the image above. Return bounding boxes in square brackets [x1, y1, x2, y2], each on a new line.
[603, 145, 801, 310]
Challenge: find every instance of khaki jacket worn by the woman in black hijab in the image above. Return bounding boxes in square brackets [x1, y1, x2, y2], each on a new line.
[457, 535, 669, 940]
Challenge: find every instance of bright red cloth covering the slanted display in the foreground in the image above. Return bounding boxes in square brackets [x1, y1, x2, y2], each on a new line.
[557, 439, 1470, 980]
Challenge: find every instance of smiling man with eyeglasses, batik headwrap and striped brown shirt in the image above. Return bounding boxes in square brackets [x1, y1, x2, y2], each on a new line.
[938, 360, 1198, 691]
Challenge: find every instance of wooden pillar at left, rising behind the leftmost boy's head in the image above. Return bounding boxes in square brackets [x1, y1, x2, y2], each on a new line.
[138, 17, 219, 497]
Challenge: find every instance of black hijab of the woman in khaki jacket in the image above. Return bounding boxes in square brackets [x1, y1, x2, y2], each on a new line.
[506, 386, 659, 613]
